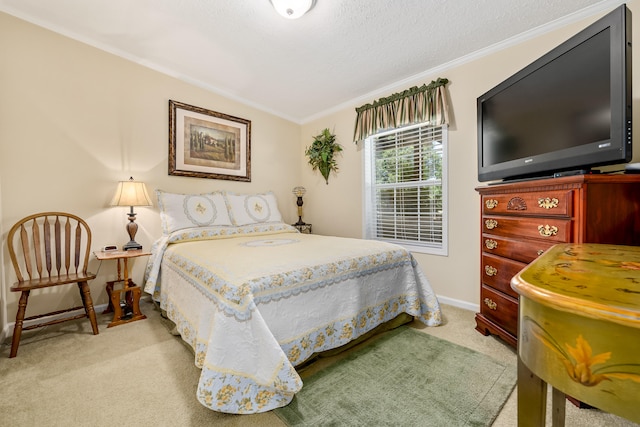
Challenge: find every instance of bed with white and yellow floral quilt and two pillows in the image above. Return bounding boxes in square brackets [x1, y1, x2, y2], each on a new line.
[144, 191, 441, 414]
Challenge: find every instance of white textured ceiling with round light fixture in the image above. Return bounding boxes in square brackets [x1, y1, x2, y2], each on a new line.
[0, 0, 623, 123]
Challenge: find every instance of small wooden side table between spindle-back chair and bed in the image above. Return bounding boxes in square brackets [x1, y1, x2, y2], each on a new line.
[94, 250, 151, 328]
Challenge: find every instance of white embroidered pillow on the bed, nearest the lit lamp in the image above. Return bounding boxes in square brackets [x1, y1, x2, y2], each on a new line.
[156, 190, 232, 234]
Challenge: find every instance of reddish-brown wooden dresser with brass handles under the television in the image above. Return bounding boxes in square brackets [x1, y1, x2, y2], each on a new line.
[476, 174, 640, 347]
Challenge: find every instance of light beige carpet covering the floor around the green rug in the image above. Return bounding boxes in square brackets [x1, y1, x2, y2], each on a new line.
[0, 299, 636, 427]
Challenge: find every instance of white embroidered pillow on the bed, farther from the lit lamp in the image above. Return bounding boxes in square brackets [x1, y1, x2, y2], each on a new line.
[225, 192, 282, 225]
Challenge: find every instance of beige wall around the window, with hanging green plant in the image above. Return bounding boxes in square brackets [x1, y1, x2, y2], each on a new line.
[302, 1, 640, 309]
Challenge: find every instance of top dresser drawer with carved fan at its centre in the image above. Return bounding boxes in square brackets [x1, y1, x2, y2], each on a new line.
[482, 190, 573, 216]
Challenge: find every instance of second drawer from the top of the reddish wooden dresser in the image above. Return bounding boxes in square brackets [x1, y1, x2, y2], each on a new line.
[482, 215, 571, 243]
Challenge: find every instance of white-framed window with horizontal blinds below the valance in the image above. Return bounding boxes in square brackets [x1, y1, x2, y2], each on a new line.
[364, 124, 447, 255]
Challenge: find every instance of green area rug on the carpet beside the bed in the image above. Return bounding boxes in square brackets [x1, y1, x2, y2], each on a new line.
[274, 326, 517, 427]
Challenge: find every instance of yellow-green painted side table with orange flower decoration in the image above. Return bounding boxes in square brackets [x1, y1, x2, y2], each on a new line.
[511, 244, 640, 426]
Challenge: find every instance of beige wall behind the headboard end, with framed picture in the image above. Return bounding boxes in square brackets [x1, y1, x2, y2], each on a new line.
[0, 13, 302, 334]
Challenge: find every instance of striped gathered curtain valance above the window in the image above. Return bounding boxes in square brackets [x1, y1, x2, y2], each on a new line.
[353, 78, 449, 142]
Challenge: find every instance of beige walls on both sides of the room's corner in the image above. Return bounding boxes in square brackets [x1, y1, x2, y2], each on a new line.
[0, 0, 640, 338]
